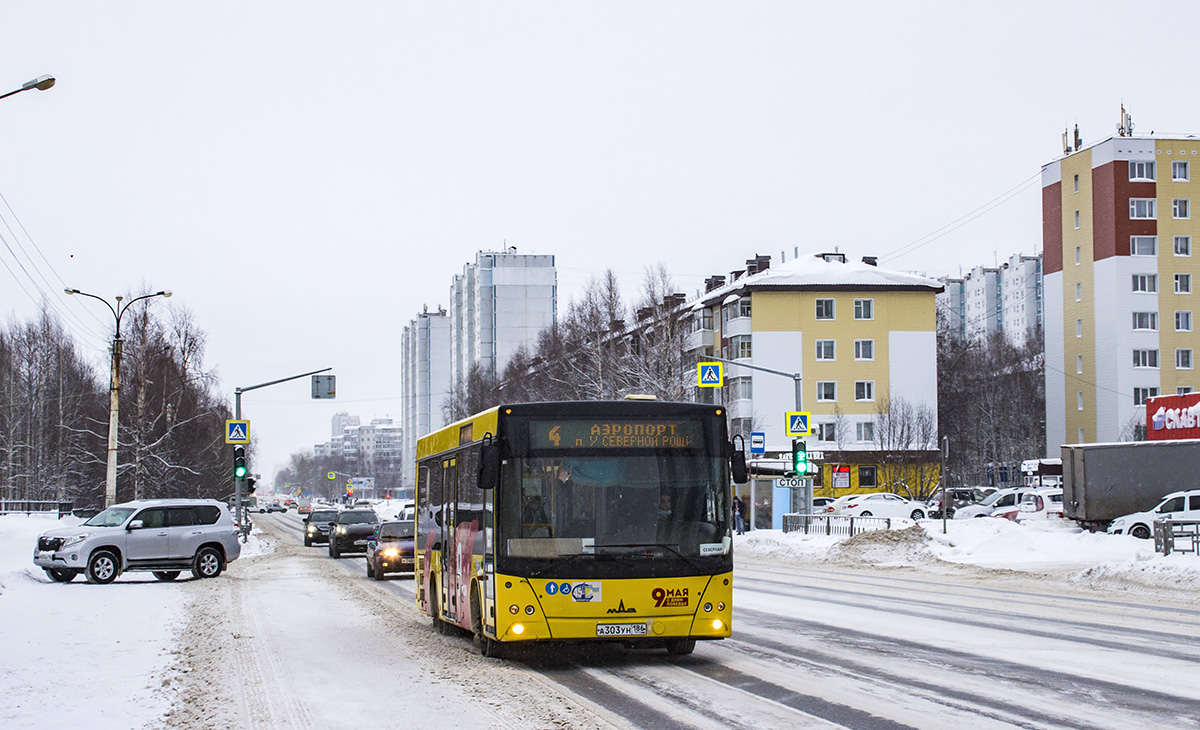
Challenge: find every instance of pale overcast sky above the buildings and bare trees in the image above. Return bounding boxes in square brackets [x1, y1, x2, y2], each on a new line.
[0, 0, 1200, 478]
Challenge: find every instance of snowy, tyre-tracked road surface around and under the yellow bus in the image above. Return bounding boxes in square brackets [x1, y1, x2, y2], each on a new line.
[172, 514, 1200, 730]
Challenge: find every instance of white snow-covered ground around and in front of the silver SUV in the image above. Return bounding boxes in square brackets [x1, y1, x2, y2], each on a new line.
[0, 515, 185, 730]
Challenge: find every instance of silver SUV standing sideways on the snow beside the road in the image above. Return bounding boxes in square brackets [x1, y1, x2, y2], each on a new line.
[34, 499, 241, 584]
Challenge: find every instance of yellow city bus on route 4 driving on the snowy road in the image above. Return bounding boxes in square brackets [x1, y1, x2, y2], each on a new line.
[415, 400, 745, 657]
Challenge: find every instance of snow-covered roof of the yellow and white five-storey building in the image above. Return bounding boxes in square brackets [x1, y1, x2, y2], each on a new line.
[689, 255, 943, 307]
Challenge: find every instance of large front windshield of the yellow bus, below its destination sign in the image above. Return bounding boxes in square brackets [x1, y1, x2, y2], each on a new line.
[497, 450, 728, 560]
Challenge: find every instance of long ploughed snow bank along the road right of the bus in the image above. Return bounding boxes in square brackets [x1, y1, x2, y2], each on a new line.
[734, 519, 1200, 594]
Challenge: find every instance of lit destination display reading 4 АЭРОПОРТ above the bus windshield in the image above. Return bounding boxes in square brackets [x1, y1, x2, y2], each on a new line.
[529, 419, 704, 449]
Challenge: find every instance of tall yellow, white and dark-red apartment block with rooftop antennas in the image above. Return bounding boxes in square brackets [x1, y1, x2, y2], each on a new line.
[1042, 130, 1200, 456]
